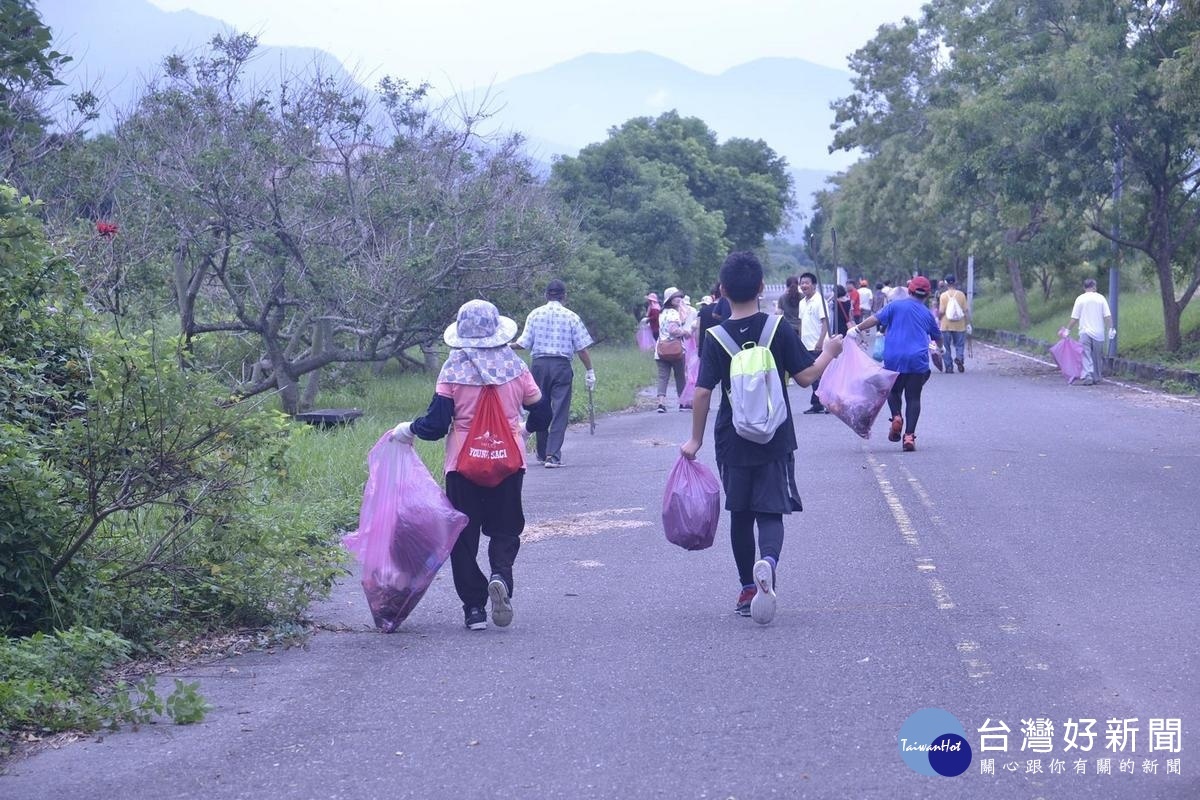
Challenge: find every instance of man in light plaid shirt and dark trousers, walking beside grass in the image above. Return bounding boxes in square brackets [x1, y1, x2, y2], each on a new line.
[511, 278, 596, 469]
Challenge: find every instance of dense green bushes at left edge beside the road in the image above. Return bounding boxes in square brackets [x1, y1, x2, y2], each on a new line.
[0, 187, 340, 638]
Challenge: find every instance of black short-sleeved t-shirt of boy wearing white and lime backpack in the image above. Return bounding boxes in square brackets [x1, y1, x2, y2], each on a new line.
[696, 312, 812, 467]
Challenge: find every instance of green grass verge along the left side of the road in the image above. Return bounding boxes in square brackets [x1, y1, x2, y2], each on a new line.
[287, 345, 655, 530]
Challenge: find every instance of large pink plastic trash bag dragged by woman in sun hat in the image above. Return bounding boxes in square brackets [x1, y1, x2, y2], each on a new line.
[342, 431, 467, 633]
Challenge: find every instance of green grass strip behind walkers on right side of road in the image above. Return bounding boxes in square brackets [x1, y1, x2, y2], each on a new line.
[973, 289, 1200, 372]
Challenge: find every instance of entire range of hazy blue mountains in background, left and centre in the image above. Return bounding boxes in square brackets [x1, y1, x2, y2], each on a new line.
[38, 0, 854, 237]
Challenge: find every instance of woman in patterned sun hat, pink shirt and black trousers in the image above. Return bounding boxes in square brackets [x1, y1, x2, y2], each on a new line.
[392, 300, 550, 631]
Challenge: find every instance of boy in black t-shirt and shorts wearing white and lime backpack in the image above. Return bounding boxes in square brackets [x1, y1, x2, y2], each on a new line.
[679, 252, 842, 625]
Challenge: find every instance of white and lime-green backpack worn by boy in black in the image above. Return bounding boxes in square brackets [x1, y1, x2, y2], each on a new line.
[708, 314, 787, 445]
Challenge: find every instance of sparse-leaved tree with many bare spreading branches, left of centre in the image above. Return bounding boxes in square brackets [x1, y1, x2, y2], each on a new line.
[116, 36, 570, 413]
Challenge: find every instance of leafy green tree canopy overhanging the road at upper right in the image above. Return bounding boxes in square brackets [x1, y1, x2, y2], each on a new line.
[821, 0, 1200, 350]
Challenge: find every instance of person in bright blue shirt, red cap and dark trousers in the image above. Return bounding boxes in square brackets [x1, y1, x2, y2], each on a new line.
[847, 276, 942, 452]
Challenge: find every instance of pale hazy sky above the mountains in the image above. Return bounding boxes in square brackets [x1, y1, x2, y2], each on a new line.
[151, 0, 923, 91]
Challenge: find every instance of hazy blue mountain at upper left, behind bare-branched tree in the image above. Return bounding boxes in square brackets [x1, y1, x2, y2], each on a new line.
[37, 0, 364, 131]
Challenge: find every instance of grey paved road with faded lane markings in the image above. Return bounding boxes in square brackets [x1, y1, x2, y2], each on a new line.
[0, 345, 1200, 800]
